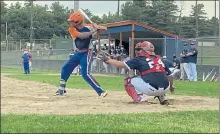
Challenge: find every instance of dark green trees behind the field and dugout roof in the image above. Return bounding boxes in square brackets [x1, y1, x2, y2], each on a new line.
[1, 0, 219, 39]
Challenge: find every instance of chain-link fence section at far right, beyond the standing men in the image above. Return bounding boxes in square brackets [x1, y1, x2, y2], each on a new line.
[195, 38, 220, 81]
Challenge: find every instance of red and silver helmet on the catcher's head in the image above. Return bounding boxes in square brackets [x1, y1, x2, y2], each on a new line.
[135, 41, 155, 57]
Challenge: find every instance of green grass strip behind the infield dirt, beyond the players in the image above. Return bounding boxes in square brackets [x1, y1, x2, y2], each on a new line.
[1, 68, 218, 97]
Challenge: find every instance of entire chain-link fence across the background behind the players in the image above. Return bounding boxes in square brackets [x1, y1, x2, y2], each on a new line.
[1, 38, 220, 81]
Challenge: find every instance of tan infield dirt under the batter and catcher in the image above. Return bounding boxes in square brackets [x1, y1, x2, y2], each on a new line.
[1, 76, 219, 115]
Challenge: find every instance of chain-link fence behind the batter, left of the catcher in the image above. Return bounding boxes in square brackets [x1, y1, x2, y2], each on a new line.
[1, 39, 128, 75]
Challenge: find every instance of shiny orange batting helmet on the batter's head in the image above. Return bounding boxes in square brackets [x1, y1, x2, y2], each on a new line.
[68, 12, 84, 26]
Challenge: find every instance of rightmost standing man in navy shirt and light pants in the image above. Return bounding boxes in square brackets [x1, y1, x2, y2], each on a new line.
[187, 43, 198, 81]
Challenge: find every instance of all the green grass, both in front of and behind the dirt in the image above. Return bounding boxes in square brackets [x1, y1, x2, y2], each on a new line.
[1, 68, 219, 133]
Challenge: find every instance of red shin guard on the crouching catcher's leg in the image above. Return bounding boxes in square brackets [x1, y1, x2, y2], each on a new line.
[124, 77, 141, 102]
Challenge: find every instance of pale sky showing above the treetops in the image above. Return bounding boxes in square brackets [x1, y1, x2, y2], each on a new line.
[5, 0, 219, 18]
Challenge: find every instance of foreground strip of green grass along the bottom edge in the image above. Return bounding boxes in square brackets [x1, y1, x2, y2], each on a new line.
[1, 111, 218, 133]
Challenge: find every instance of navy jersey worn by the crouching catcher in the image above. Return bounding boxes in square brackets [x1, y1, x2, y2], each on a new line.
[124, 57, 171, 89]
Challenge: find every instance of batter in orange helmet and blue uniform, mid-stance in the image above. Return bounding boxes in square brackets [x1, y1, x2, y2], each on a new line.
[56, 12, 107, 97]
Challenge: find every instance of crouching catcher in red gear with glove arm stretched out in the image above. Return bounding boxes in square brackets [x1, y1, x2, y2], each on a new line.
[98, 41, 172, 105]
